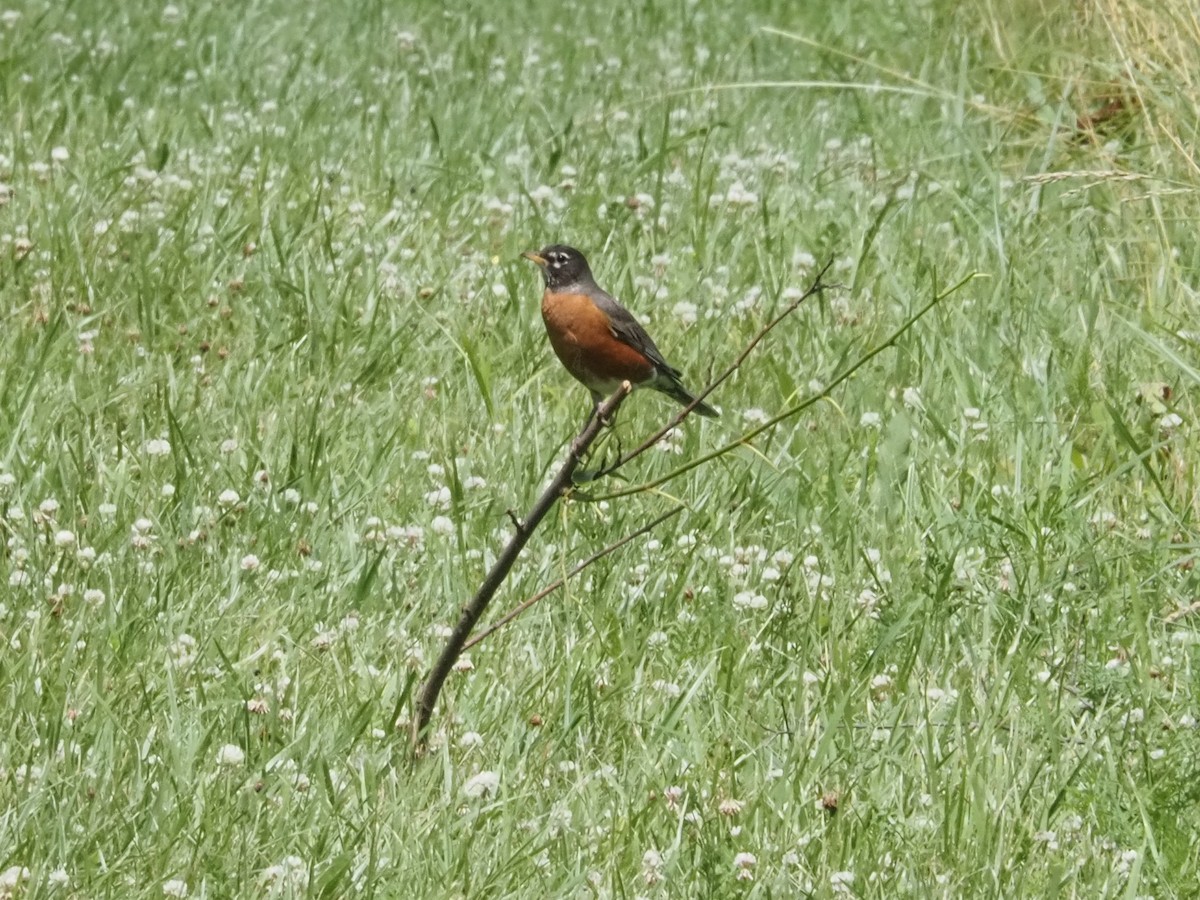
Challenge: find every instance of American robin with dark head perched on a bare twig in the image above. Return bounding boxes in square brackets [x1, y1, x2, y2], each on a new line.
[521, 244, 718, 416]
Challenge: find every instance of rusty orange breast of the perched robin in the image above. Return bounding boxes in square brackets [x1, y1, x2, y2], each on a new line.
[541, 290, 654, 390]
